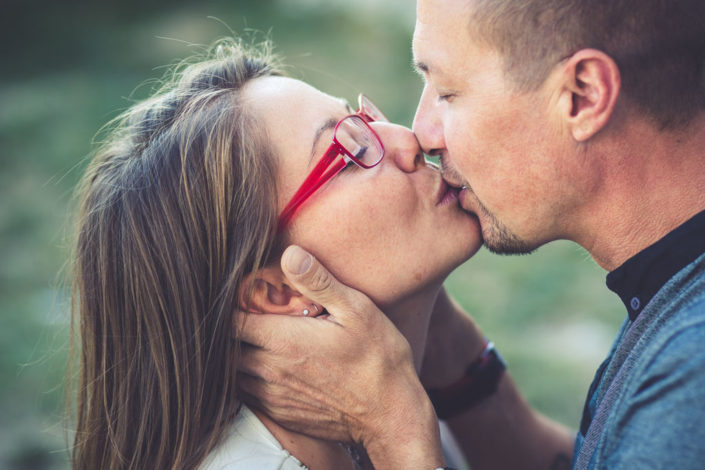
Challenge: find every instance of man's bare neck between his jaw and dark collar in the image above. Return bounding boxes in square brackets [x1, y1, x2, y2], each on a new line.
[575, 111, 705, 271]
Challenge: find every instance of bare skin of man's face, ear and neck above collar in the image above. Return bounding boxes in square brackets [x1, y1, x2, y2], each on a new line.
[413, 0, 702, 269]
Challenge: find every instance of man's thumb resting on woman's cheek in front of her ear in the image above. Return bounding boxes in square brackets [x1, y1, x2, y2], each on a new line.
[281, 245, 377, 323]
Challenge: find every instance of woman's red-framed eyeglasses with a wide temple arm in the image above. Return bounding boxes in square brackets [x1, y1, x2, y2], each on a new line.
[277, 94, 389, 233]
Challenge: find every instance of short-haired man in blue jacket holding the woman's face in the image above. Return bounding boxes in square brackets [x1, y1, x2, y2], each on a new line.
[242, 0, 705, 469]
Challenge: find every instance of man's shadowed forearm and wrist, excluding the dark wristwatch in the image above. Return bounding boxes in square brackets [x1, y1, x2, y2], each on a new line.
[421, 291, 574, 470]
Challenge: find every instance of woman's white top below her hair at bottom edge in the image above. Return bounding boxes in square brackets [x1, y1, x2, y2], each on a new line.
[199, 405, 307, 470]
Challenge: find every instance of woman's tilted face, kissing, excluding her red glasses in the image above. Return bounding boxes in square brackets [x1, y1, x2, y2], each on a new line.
[244, 77, 482, 306]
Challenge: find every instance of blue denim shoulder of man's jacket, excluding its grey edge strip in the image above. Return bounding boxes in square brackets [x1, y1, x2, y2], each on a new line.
[601, 298, 705, 469]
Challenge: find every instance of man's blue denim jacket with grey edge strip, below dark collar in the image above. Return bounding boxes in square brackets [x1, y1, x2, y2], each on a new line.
[573, 255, 705, 470]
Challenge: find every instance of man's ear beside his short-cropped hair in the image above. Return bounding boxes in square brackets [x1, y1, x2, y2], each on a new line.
[560, 49, 621, 142]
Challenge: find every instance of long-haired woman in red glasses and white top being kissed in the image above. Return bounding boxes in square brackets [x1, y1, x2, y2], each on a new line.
[73, 41, 481, 470]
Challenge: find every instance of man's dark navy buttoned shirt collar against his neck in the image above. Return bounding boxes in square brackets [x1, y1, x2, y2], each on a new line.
[607, 211, 705, 321]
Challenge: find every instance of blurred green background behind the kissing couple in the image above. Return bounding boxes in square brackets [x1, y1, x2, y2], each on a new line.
[0, 0, 623, 469]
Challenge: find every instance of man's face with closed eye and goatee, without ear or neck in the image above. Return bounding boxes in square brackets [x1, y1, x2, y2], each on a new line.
[413, 0, 580, 253]
